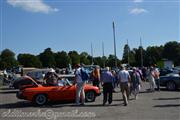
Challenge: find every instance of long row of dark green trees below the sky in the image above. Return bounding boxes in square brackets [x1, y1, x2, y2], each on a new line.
[0, 41, 180, 69]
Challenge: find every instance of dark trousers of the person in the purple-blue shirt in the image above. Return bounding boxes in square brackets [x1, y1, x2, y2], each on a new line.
[103, 83, 113, 104]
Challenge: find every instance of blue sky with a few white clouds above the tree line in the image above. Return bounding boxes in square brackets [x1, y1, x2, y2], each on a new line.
[0, 0, 180, 59]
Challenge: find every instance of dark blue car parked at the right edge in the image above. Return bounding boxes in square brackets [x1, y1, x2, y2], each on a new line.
[160, 74, 180, 90]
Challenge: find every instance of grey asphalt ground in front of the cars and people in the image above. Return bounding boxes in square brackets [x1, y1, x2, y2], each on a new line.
[0, 83, 180, 120]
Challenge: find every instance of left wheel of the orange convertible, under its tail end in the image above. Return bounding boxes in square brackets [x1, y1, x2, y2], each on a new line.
[34, 94, 47, 105]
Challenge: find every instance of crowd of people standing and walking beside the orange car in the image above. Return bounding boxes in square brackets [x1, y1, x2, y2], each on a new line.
[75, 64, 159, 106]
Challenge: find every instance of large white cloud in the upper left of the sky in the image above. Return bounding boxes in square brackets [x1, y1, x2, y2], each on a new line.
[7, 0, 58, 13]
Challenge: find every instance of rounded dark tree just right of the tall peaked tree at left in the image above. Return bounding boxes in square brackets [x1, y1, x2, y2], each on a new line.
[55, 51, 71, 68]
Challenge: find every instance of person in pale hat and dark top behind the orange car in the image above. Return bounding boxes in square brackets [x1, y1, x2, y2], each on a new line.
[44, 68, 58, 86]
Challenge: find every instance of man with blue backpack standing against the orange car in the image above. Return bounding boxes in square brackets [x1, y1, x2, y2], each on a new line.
[75, 64, 85, 105]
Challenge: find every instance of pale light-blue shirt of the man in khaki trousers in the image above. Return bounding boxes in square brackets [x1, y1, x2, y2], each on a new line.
[118, 70, 130, 83]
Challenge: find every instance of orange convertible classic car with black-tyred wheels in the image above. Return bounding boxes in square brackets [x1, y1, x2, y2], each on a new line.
[16, 77, 101, 105]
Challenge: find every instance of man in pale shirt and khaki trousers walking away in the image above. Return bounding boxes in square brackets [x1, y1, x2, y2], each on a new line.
[118, 67, 131, 106]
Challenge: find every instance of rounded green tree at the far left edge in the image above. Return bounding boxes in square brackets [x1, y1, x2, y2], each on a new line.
[0, 49, 18, 69]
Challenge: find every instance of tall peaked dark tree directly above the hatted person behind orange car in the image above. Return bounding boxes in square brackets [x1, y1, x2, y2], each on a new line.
[39, 48, 56, 67]
